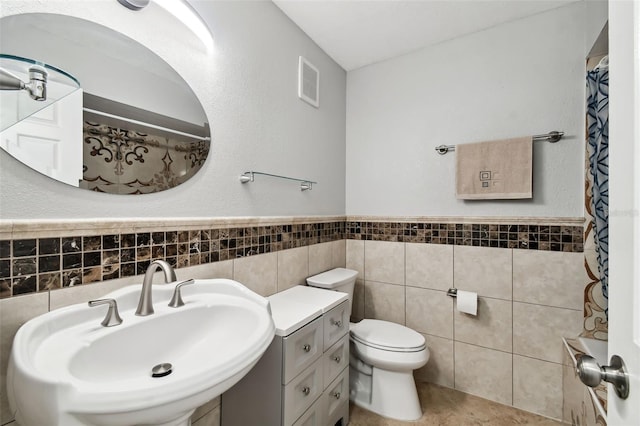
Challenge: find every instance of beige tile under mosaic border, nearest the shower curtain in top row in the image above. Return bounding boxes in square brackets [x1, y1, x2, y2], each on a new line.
[513, 250, 590, 309]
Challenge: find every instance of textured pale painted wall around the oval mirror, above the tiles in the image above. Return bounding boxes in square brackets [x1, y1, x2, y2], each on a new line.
[0, 0, 346, 219]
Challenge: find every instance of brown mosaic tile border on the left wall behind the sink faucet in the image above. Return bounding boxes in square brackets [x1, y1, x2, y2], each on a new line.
[0, 221, 344, 298]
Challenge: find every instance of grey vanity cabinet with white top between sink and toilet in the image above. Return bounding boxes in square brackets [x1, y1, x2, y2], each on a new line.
[221, 286, 349, 426]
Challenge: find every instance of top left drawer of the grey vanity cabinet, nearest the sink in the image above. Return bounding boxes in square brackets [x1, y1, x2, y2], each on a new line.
[282, 317, 322, 385]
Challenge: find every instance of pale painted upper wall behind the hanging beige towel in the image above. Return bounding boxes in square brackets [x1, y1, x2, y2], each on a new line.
[346, 2, 606, 217]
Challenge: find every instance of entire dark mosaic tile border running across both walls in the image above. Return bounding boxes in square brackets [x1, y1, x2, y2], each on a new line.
[0, 217, 583, 299]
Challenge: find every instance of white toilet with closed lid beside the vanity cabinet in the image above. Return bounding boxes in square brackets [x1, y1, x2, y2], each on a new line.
[307, 268, 429, 421]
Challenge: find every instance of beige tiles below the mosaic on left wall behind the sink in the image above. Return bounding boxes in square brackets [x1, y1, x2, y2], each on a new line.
[0, 233, 346, 426]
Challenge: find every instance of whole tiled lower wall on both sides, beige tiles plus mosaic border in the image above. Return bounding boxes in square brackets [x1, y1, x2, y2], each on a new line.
[0, 217, 586, 426]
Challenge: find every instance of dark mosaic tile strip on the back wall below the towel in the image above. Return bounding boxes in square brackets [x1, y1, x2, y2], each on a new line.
[345, 221, 584, 252]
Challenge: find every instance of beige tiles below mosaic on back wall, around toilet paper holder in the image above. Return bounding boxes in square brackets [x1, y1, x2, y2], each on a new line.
[346, 240, 586, 419]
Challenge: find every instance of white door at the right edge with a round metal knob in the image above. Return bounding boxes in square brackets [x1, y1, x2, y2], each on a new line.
[607, 0, 640, 426]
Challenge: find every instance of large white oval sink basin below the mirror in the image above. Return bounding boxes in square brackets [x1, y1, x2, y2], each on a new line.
[7, 279, 275, 426]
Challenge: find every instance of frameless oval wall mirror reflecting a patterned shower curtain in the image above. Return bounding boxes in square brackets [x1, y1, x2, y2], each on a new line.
[0, 13, 211, 194]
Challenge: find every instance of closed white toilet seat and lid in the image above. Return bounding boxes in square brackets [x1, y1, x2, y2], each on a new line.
[350, 319, 426, 352]
